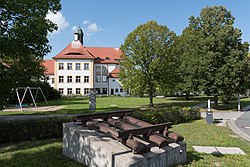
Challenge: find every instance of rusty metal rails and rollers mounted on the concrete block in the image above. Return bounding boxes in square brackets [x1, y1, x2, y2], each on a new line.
[74, 110, 184, 154]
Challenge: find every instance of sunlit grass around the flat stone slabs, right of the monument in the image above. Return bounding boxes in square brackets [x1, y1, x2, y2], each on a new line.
[172, 120, 250, 167]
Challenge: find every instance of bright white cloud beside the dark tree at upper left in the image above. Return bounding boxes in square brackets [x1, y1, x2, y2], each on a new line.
[46, 11, 69, 34]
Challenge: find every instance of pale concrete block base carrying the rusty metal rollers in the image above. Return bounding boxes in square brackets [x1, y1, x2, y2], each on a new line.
[63, 123, 186, 167]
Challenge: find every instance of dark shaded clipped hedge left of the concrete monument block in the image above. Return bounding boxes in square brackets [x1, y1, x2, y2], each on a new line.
[0, 117, 73, 144]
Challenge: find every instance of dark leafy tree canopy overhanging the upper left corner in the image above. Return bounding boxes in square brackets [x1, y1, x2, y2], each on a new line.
[0, 0, 61, 59]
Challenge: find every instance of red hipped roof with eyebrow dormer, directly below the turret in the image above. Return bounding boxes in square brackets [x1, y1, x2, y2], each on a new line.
[53, 40, 94, 59]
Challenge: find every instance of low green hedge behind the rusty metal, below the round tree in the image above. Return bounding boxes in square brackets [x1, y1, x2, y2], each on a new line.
[132, 107, 201, 124]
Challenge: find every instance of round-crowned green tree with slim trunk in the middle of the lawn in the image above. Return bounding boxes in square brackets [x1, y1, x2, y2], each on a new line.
[119, 21, 177, 107]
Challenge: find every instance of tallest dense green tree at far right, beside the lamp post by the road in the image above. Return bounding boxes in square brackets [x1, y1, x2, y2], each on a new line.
[183, 6, 249, 107]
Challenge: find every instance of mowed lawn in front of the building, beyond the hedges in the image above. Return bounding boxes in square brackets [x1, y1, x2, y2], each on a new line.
[0, 96, 207, 115]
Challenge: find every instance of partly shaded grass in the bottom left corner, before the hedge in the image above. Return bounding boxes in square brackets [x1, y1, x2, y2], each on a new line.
[0, 139, 82, 167]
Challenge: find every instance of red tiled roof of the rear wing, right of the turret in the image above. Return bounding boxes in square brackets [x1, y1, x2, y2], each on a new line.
[86, 47, 122, 64]
